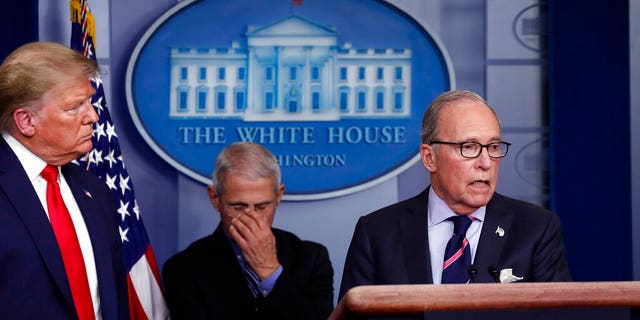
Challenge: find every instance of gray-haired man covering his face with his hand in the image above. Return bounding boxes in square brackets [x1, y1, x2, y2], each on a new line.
[163, 142, 333, 319]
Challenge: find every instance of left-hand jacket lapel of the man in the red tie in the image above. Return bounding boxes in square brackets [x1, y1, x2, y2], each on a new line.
[0, 137, 75, 312]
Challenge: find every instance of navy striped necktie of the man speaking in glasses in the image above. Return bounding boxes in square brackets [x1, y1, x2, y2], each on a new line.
[442, 215, 474, 283]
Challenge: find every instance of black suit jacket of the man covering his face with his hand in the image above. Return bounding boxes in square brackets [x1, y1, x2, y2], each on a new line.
[162, 225, 333, 320]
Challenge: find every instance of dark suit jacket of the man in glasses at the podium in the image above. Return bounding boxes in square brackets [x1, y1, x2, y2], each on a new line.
[340, 189, 571, 297]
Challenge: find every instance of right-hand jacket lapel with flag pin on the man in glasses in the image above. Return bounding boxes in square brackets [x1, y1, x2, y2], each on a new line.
[474, 193, 513, 282]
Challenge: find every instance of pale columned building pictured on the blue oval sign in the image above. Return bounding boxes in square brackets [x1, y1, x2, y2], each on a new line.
[170, 15, 411, 121]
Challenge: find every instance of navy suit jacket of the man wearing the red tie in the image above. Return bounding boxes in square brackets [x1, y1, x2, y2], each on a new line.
[0, 136, 129, 319]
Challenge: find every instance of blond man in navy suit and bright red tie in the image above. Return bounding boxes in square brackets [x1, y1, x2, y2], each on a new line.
[0, 43, 129, 319]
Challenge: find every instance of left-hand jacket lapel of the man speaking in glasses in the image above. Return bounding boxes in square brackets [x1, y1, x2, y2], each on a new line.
[400, 189, 433, 284]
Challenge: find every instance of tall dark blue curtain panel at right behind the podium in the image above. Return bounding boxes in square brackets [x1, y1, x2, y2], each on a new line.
[548, 0, 632, 281]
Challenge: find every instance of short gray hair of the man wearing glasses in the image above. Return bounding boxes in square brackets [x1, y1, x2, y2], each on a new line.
[420, 90, 500, 144]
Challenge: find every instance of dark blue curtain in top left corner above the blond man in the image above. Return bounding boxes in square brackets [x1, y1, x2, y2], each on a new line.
[0, 0, 38, 61]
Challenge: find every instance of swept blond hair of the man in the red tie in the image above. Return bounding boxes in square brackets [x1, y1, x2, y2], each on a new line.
[0, 42, 100, 130]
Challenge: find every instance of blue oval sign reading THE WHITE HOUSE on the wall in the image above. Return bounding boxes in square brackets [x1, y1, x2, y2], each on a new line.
[126, 0, 454, 200]
